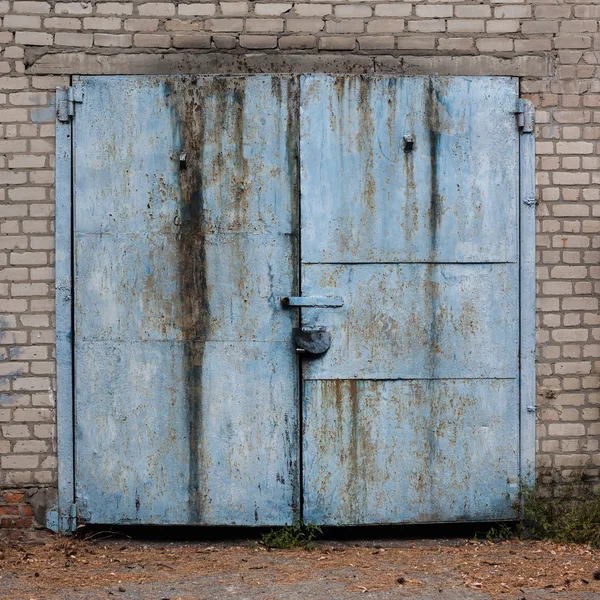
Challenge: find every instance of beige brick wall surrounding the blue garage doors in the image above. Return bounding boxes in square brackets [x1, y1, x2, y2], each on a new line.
[0, 0, 600, 519]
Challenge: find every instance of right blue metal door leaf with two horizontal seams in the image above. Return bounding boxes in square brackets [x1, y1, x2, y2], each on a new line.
[300, 75, 519, 524]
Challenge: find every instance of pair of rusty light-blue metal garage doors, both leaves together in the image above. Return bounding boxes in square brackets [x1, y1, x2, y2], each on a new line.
[70, 75, 530, 525]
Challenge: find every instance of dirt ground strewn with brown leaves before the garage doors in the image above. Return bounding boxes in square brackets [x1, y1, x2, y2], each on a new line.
[0, 536, 600, 600]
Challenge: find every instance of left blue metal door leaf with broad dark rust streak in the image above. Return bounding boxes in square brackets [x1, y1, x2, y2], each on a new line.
[73, 76, 299, 525]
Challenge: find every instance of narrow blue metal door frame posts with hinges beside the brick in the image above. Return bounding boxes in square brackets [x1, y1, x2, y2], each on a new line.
[52, 73, 536, 533]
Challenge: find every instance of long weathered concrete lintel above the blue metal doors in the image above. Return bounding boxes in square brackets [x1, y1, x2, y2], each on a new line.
[28, 52, 554, 77]
